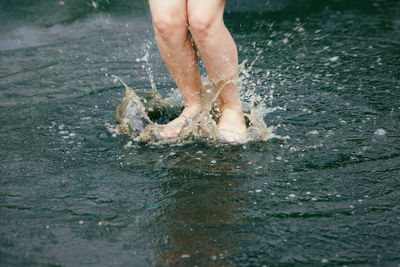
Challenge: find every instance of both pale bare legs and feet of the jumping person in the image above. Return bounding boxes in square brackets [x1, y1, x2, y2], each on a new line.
[149, 0, 247, 142]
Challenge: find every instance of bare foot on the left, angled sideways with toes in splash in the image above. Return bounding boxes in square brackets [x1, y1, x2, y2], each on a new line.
[160, 104, 200, 138]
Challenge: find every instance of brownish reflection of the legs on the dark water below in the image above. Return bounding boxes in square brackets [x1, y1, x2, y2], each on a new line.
[157, 148, 252, 266]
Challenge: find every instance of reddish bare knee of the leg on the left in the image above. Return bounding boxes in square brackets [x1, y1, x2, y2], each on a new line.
[153, 16, 187, 40]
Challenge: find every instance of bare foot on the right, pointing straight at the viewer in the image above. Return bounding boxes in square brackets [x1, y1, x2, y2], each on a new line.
[218, 108, 247, 143]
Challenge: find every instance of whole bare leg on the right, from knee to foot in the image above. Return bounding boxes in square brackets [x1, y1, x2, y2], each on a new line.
[187, 0, 247, 142]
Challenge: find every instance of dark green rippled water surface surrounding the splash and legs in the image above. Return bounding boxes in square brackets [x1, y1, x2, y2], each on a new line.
[0, 0, 400, 266]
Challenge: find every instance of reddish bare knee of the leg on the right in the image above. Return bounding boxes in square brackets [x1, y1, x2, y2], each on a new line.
[189, 15, 218, 43]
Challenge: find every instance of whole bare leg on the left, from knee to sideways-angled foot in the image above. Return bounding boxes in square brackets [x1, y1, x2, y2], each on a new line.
[149, 0, 202, 138]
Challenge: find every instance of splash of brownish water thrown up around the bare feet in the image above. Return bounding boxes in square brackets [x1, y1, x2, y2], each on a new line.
[113, 52, 282, 144]
